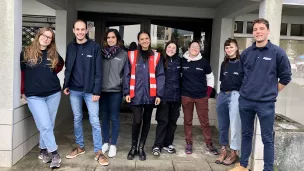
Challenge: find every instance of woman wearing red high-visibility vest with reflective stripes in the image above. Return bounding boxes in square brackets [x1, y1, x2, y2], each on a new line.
[124, 31, 165, 160]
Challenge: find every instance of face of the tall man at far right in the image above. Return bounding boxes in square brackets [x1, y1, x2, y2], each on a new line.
[253, 23, 270, 43]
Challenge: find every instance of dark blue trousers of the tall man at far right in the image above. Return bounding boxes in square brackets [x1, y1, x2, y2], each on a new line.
[239, 97, 275, 171]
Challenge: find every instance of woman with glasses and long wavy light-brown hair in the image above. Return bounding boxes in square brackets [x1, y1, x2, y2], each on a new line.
[20, 27, 64, 168]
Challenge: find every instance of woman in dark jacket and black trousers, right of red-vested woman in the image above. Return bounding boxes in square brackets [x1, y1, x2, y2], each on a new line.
[152, 41, 181, 156]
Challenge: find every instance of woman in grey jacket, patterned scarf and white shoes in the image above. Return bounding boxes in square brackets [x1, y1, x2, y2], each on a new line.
[100, 29, 128, 157]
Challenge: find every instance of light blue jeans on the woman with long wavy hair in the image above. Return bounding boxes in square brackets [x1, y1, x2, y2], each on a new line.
[26, 92, 61, 152]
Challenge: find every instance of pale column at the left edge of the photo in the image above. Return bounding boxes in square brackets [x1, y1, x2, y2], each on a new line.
[0, 0, 23, 167]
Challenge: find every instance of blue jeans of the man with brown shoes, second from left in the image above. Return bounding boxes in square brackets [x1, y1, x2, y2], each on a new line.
[70, 90, 102, 152]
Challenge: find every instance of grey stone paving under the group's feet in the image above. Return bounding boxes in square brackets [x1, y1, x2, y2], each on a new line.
[0, 114, 231, 171]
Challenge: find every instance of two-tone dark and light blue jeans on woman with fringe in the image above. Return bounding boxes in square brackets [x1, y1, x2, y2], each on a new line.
[216, 91, 242, 150]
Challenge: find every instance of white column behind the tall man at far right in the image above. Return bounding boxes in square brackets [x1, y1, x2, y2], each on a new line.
[250, 0, 284, 171]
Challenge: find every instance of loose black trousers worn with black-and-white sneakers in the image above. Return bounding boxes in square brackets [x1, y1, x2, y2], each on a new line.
[154, 102, 181, 148]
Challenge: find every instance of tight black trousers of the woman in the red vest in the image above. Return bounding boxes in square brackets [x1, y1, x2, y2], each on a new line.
[132, 105, 154, 146]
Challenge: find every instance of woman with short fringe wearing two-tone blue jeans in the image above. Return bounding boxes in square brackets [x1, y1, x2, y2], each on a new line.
[215, 38, 242, 165]
